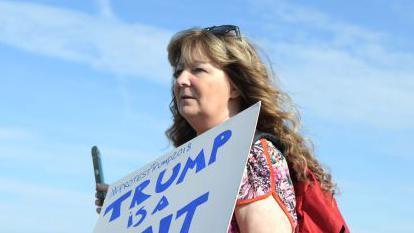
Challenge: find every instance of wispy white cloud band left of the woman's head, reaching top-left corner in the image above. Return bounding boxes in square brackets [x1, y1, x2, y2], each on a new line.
[0, 0, 171, 84]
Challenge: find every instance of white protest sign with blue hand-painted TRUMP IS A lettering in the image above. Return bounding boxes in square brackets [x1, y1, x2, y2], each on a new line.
[94, 103, 260, 233]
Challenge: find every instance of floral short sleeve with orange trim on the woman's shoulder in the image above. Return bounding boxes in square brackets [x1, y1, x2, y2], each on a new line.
[237, 139, 297, 228]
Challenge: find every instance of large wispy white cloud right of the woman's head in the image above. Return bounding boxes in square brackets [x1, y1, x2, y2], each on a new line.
[247, 1, 414, 129]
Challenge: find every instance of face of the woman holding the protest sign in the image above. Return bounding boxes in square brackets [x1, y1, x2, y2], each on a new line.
[174, 56, 239, 134]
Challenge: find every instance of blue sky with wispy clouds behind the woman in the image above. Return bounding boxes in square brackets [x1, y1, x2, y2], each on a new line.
[0, 0, 414, 233]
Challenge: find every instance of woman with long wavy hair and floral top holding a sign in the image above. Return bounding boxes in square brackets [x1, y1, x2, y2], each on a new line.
[96, 25, 340, 233]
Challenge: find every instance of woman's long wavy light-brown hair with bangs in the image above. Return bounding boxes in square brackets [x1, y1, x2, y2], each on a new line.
[165, 28, 335, 194]
